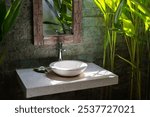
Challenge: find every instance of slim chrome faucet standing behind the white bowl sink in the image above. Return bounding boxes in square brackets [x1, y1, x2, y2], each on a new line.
[57, 39, 65, 61]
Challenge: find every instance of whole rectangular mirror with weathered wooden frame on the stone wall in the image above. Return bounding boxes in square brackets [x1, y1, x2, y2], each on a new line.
[33, 0, 82, 45]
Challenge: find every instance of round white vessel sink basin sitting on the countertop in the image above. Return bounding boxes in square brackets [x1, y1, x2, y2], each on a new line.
[49, 60, 88, 77]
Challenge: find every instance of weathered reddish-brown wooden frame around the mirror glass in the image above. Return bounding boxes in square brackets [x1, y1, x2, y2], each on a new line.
[33, 0, 82, 45]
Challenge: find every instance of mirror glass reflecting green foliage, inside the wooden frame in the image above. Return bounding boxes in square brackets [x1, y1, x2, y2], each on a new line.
[42, 0, 73, 36]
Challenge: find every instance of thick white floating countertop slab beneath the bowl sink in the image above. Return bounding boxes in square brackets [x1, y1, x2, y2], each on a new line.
[16, 63, 118, 98]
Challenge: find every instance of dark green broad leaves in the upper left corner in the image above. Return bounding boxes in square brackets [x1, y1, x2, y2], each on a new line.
[0, 0, 22, 63]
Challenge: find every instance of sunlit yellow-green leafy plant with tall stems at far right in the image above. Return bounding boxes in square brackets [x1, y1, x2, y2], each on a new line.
[115, 0, 150, 99]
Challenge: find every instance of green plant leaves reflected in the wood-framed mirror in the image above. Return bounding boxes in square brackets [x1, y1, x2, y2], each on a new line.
[43, 0, 72, 34]
